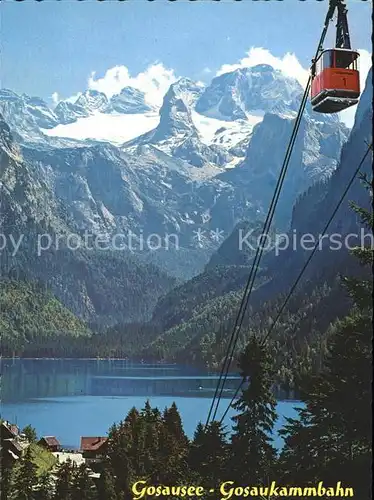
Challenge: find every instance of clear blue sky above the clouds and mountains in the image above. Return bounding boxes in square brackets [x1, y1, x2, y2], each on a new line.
[0, 0, 372, 103]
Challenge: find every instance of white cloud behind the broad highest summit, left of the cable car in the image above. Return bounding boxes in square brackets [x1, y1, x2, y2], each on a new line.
[216, 47, 309, 86]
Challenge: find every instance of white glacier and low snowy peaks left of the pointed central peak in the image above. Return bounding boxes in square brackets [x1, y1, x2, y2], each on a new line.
[0, 87, 158, 144]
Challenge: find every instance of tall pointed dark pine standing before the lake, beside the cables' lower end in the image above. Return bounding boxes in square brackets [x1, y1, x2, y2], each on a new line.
[229, 336, 276, 485]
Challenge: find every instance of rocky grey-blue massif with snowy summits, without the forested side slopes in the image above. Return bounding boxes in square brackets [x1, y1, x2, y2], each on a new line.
[0, 61, 348, 278]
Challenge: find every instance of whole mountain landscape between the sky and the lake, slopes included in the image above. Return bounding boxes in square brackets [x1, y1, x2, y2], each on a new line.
[0, 60, 372, 387]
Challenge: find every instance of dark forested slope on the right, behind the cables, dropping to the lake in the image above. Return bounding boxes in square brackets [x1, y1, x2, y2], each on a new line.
[142, 66, 373, 370]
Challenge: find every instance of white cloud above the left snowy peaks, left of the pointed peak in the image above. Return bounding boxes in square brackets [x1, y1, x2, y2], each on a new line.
[88, 63, 177, 106]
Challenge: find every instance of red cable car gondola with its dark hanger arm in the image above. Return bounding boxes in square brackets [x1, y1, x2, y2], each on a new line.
[311, 0, 360, 113]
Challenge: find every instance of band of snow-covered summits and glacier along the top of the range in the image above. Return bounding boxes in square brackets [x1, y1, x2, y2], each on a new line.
[0, 65, 344, 160]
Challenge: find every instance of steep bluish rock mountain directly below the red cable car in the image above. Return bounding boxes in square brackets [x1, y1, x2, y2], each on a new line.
[220, 113, 347, 229]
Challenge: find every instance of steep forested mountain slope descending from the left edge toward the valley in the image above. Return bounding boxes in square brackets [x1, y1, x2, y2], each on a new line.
[0, 117, 174, 334]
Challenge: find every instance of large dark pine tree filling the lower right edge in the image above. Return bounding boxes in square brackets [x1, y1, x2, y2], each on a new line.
[280, 198, 373, 498]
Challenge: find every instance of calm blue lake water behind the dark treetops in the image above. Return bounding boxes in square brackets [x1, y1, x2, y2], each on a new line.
[0, 359, 299, 448]
